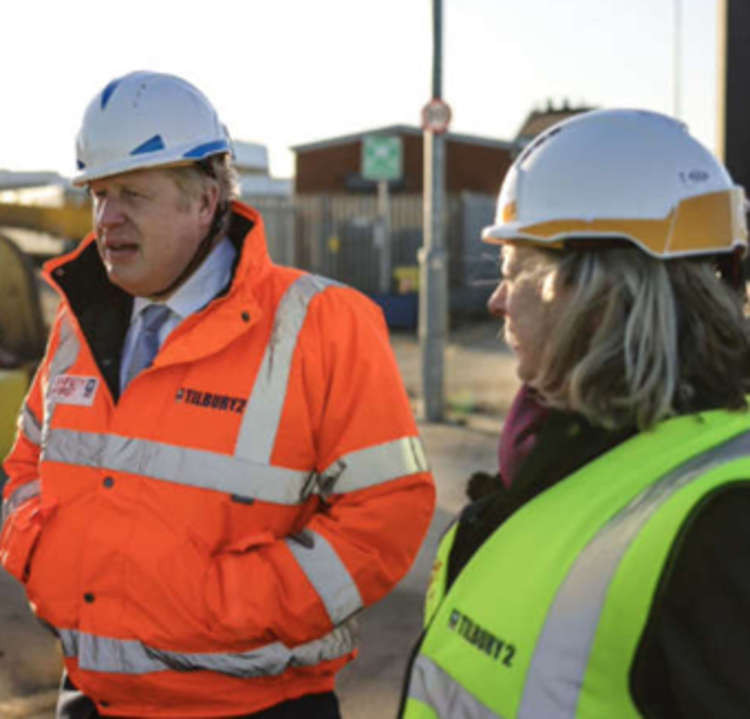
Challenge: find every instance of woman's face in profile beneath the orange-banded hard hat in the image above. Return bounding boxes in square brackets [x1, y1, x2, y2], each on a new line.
[487, 243, 567, 385]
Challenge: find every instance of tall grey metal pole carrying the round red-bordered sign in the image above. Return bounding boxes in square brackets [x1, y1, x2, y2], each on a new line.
[419, 0, 448, 422]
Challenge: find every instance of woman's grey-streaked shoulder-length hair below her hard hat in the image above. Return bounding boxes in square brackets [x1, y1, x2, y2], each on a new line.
[533, 247, 750, 429]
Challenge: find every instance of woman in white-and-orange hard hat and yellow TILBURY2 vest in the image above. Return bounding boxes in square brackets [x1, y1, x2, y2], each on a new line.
[401, 110, 750, 719]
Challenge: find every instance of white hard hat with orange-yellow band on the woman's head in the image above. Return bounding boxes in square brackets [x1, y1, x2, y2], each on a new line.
[482, 110, 747, 258]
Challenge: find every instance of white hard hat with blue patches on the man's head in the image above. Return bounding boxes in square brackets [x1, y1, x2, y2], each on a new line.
[73, 72, 232, 185]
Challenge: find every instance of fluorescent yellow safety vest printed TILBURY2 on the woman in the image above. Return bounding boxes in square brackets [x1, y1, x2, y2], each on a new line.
[402, 411, 750, 719]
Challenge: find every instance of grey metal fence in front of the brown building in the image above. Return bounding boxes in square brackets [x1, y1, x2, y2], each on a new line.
[243, 193, 497, 314]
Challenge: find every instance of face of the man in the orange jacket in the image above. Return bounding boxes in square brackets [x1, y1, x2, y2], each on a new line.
[89, 169, 215, 297]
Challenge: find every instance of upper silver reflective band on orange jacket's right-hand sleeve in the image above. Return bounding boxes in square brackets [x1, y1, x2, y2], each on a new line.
[332, 437, 428, 492]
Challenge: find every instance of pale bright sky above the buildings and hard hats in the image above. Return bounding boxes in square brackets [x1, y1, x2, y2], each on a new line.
[0, 0, 717, 177]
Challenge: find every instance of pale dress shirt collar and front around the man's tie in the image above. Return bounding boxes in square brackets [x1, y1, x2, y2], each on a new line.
[120, 237, 237, 392]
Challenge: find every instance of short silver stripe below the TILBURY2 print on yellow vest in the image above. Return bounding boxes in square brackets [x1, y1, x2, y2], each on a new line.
[409, 654, 502, 719]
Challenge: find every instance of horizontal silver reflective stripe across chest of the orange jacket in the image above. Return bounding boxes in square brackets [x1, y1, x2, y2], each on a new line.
[42, 429, 309, 504]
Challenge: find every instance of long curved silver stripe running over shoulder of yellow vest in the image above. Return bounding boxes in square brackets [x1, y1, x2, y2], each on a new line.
[518, 433, 750, 719]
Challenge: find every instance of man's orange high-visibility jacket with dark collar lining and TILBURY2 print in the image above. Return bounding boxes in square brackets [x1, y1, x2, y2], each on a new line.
[0, 203, 434, 717]
